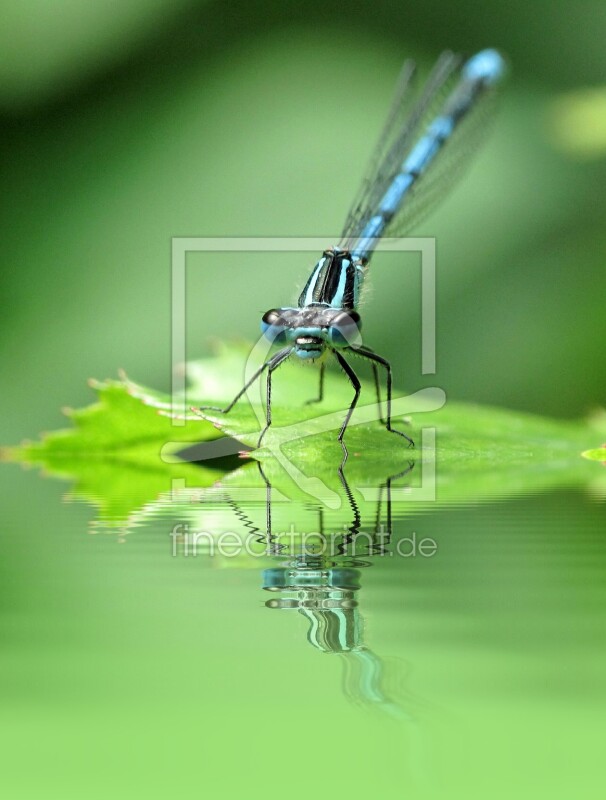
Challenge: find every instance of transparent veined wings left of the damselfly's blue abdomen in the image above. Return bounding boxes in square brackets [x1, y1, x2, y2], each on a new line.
[341, 51, 461, 247]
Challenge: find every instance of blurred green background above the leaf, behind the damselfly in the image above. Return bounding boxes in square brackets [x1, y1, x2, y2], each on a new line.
[0, 0, 606, 450]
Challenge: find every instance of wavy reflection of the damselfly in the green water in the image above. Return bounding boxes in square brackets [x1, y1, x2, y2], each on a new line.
[224, 462, 422, 720]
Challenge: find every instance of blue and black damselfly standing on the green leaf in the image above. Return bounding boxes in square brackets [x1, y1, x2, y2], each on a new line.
[199, 50, 504, 457]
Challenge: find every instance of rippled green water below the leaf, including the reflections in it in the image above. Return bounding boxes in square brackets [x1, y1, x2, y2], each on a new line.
[0, 462, 606, 798]
